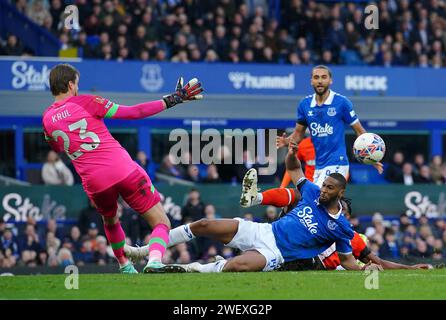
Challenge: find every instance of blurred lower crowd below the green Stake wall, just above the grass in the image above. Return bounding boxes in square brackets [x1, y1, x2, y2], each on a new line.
[0, 189, 446, 268]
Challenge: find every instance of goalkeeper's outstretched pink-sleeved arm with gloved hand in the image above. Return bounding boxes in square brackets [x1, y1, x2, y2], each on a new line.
[92, 77, 203, 120]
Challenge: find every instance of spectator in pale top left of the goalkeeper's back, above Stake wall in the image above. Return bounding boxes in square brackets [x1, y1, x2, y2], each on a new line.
[42, 150, 74, 186]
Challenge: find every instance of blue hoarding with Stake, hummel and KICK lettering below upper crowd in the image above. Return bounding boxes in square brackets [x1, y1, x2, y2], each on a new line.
[0, 58, 446, 97]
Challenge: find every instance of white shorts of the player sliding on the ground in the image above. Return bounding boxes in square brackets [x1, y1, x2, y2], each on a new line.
[226, 218, 284, 271]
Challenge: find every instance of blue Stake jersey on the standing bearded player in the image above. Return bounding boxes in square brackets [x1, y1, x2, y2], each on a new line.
[297, 90, 359, 169]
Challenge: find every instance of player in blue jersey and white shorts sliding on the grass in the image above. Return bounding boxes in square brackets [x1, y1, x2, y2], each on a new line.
[124, 142, 380, 272]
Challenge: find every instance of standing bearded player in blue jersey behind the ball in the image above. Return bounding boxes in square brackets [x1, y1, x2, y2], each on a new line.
[276, 65, 383, 187]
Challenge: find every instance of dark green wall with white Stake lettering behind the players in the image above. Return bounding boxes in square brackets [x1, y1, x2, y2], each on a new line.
[0, 184, 446, 222]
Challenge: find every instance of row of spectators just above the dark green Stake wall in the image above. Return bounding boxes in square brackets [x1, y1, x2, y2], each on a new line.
[37, 151, 446, 186]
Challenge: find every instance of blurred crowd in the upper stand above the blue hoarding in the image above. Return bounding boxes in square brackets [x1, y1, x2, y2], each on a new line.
[0, 0, 446, 68]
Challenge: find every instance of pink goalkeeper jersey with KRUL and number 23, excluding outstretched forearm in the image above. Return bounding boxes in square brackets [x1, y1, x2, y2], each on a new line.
[43, 95, 137, 194]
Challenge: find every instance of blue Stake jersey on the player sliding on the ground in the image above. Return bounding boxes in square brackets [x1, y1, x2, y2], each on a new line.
[272, 180, 354, 262]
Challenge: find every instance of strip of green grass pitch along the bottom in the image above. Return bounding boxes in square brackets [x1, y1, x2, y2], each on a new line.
[0, 269, 446, 300]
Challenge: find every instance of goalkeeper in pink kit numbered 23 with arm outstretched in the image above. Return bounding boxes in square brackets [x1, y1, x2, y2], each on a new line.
[42, 64, 203, 273]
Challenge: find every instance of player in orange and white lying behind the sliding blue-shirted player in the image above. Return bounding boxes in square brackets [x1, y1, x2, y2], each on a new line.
[240, 168, 432, 270]
